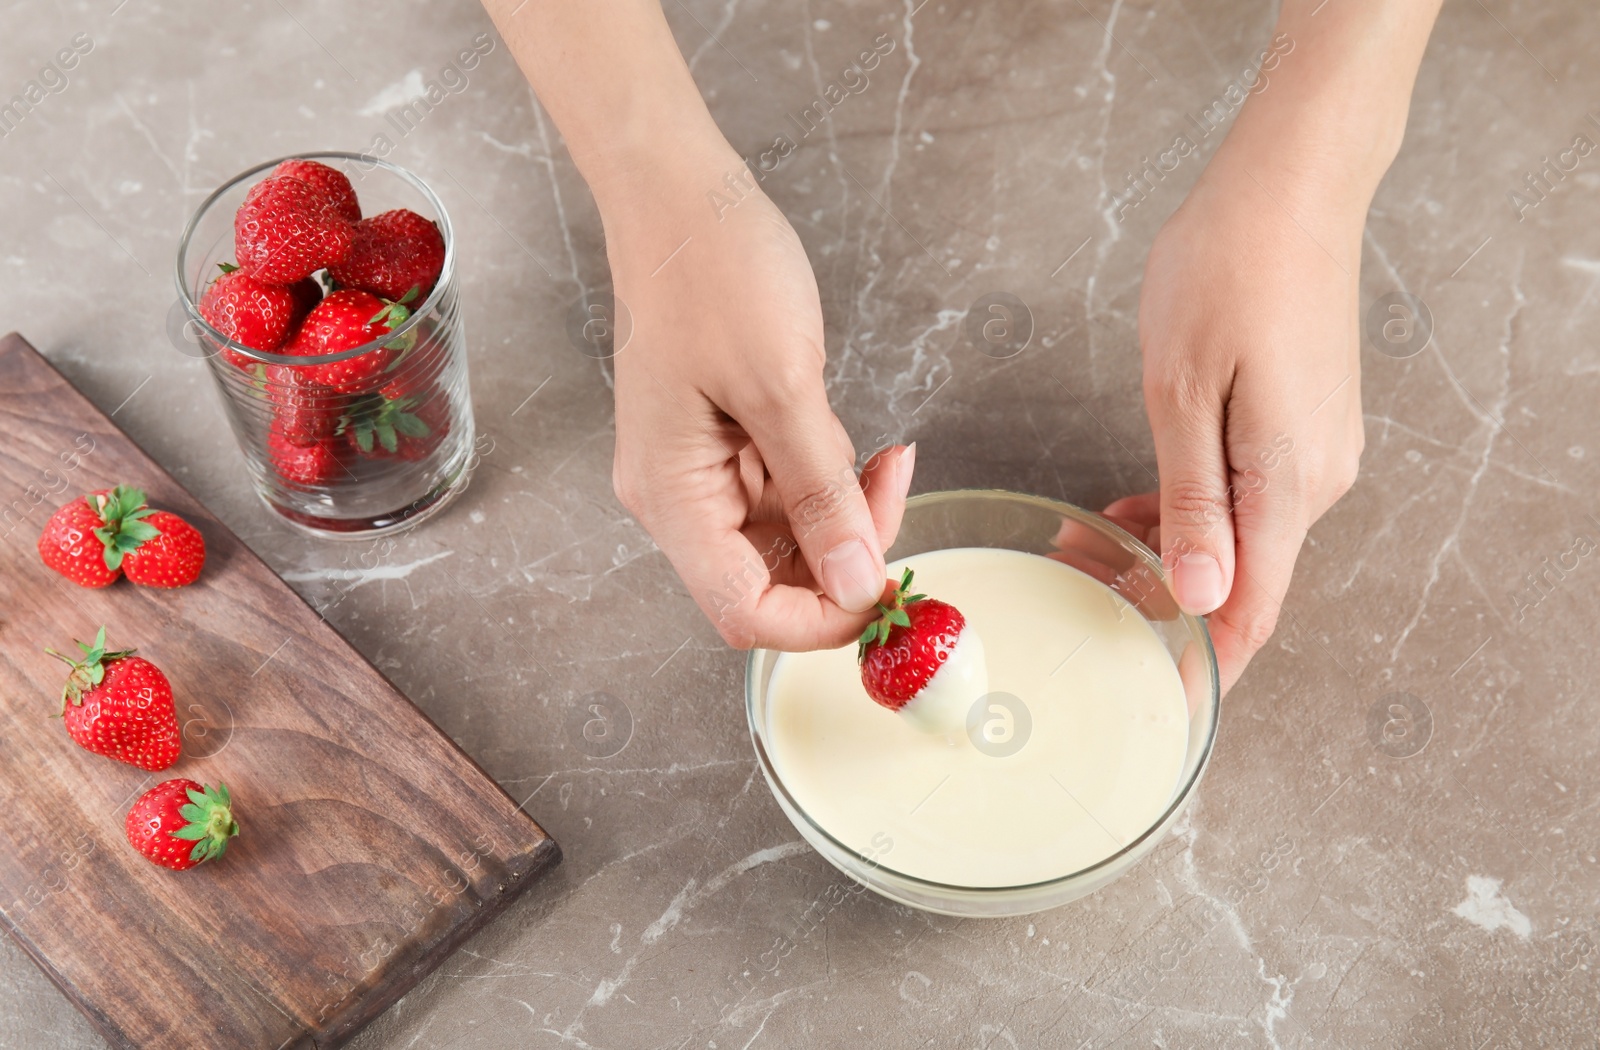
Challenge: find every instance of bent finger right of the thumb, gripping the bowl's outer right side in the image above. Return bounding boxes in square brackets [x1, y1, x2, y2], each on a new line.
[1206, 476, 1309, 693]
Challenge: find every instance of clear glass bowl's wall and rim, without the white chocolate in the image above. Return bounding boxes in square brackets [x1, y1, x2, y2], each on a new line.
[744, 490, 1221, 917]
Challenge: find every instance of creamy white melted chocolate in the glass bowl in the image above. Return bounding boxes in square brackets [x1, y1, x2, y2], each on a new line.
[766, 547, 1189, 887]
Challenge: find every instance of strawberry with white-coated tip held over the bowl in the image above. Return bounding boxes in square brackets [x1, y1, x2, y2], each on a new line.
[856, 568, 989, 731]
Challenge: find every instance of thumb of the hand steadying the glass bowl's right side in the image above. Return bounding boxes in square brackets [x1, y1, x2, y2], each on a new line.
[1150, 395, 1234, 616]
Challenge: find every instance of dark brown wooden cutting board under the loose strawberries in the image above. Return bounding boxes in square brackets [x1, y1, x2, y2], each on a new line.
[0, 335, 560, 1050]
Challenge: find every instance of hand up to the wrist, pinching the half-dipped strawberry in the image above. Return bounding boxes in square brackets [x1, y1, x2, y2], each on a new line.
[603, 150, 914, 650]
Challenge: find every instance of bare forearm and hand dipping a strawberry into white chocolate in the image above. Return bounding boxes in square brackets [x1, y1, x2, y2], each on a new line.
[485, 0, 912, 650]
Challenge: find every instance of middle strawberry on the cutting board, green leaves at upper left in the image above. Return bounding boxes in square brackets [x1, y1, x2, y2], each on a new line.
[45, 627, 182, 773]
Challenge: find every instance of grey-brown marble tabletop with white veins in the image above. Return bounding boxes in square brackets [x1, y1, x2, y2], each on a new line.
[0, 0, 1600, 1050]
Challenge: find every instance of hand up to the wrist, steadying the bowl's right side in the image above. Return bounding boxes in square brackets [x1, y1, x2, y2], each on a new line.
[1106, 146, 1366, 690]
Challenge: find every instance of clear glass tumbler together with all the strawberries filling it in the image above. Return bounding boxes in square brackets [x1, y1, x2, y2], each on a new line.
[178, 154, 472, 536]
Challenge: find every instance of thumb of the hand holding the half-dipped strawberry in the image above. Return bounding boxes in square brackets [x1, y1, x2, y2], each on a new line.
[742, 393, 886, 613]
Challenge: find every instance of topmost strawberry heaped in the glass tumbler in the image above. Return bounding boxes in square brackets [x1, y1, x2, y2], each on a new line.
[234, 174, 350, 285]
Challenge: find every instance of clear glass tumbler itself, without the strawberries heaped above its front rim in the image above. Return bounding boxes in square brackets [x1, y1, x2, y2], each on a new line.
[174, 152, 474, 539]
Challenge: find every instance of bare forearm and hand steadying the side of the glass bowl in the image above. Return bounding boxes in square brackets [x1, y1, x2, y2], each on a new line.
[1106, 0, 1440, 690]
